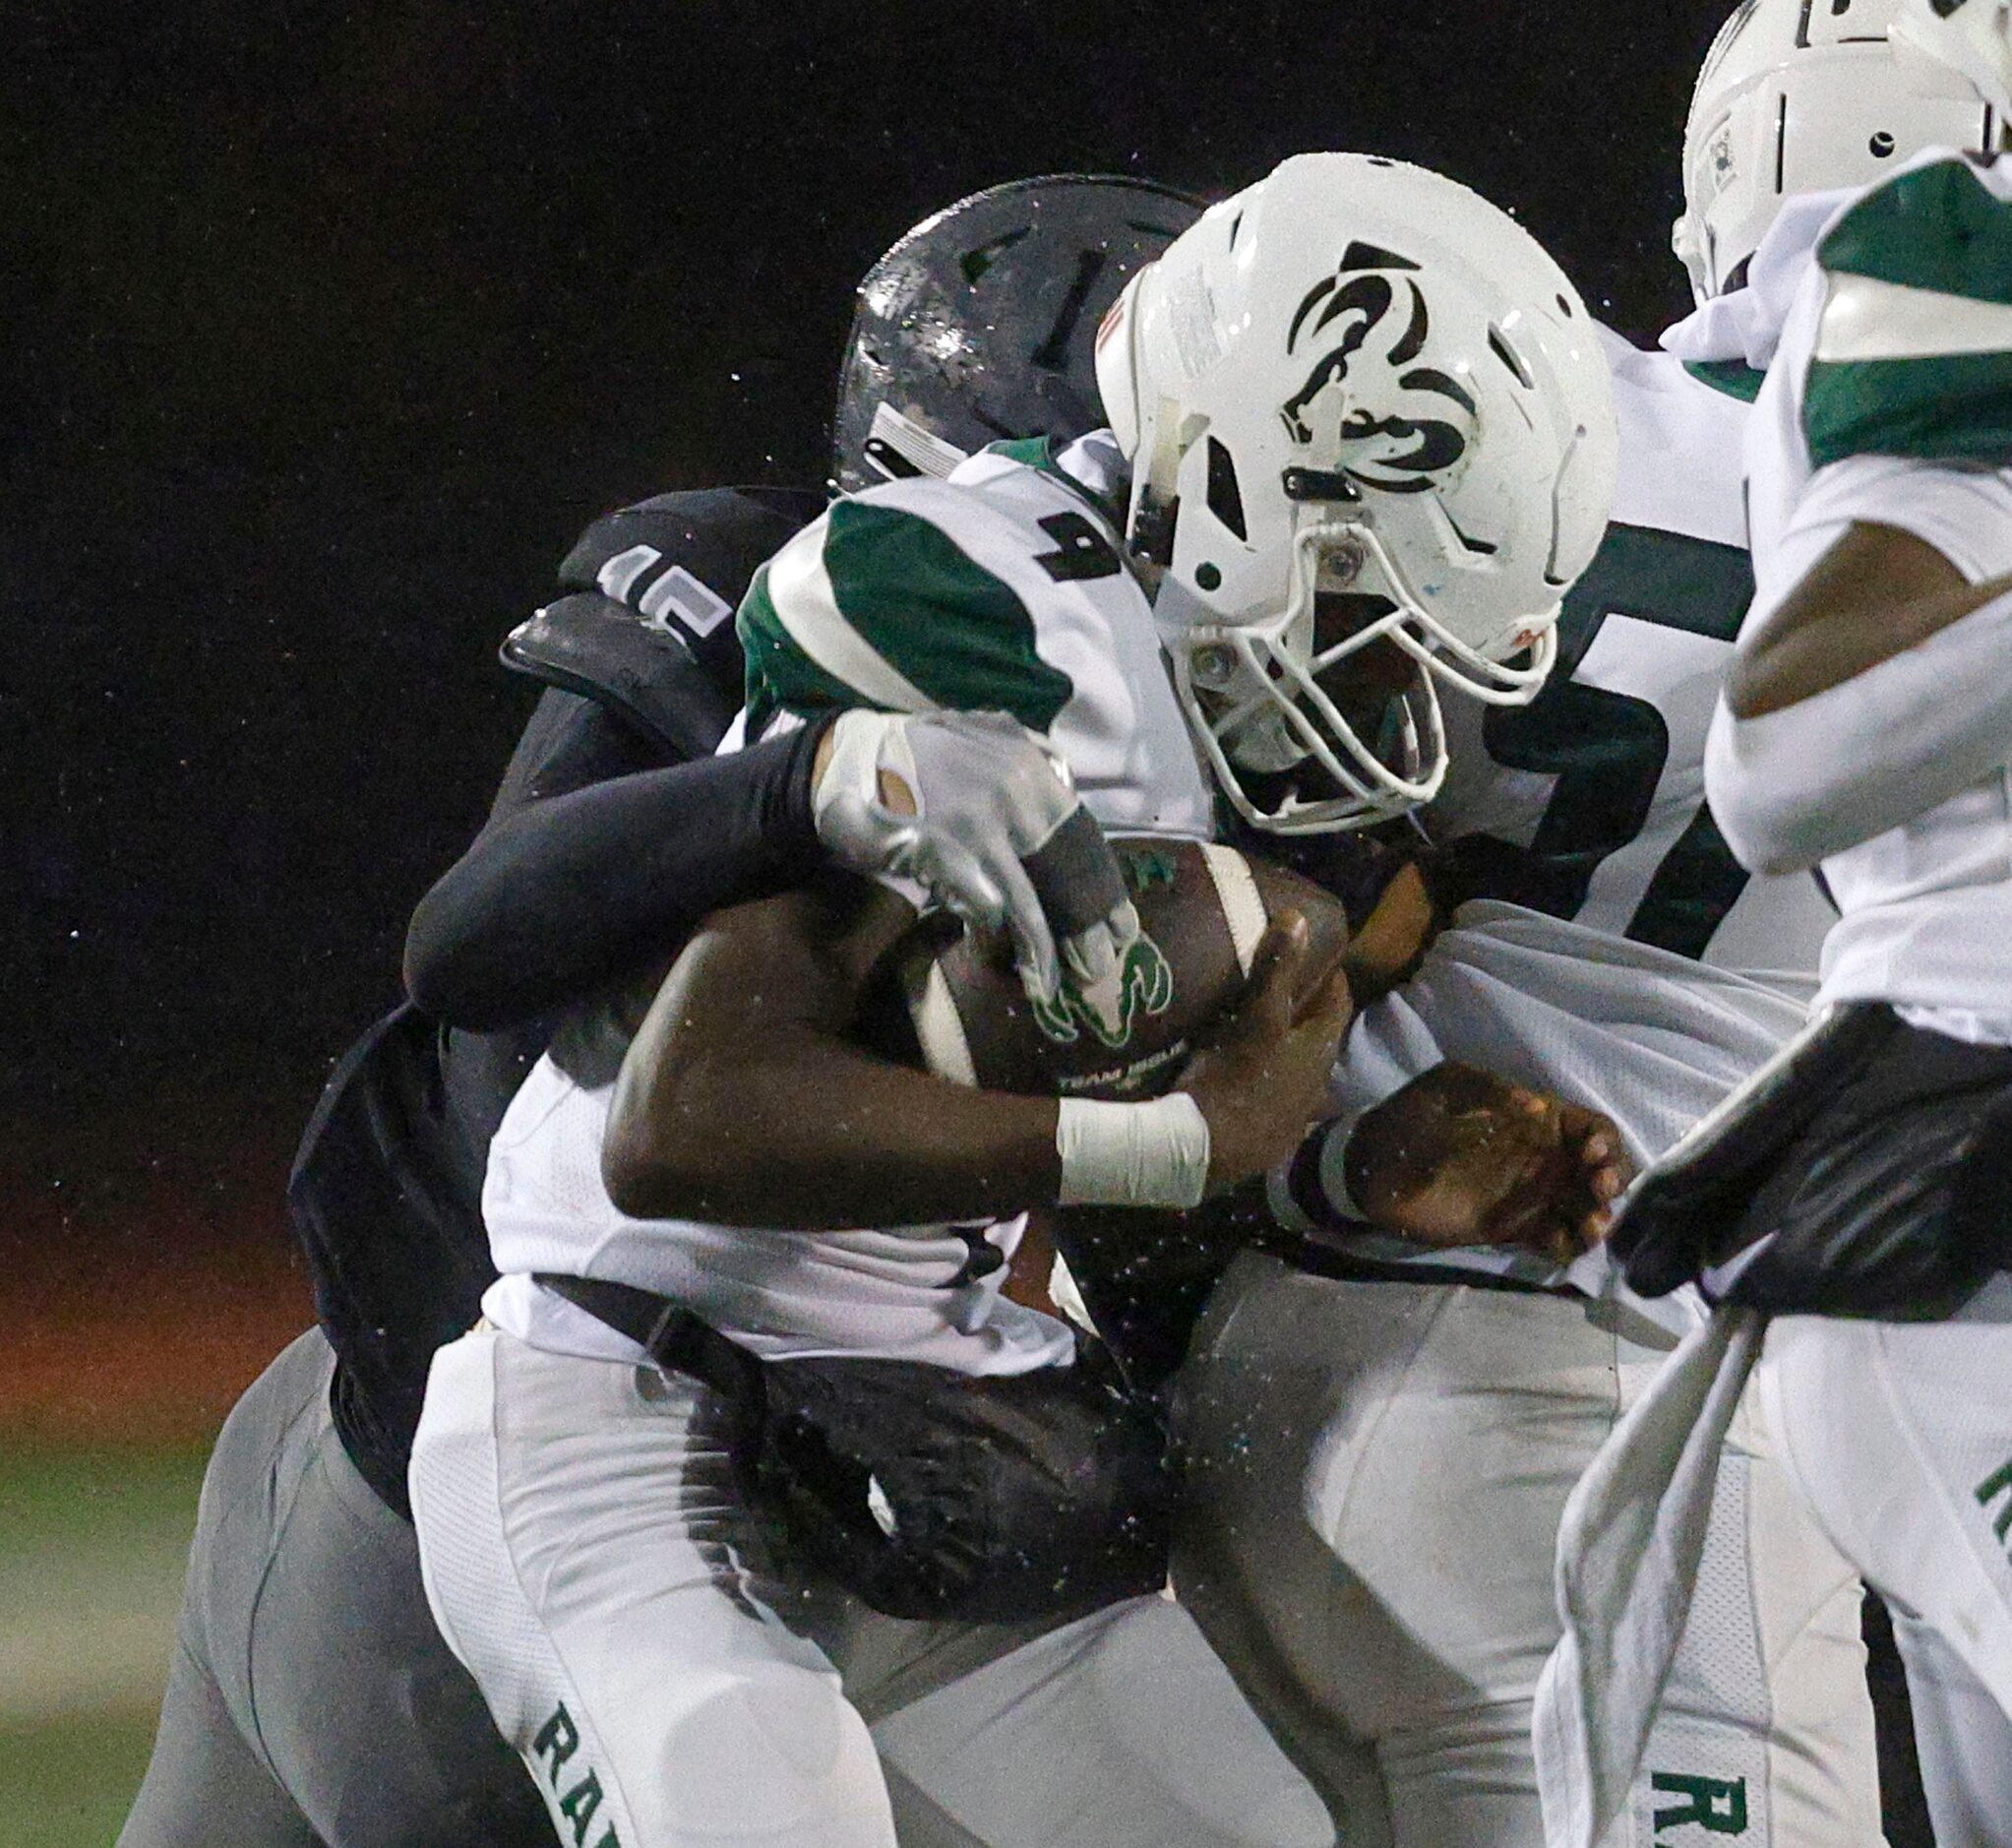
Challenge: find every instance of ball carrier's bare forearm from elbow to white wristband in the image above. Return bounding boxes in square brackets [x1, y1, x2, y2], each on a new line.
[601, 1035, 1061, 1230]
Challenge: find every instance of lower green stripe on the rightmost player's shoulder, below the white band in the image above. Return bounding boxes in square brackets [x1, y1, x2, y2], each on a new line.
[1802, 352, 2012, 469]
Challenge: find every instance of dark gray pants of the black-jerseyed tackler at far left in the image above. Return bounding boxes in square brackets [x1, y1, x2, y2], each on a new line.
[119, 1328, 551, 1848]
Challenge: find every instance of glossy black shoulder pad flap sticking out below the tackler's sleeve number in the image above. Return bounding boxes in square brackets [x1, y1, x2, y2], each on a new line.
[503, 589, 739, 763]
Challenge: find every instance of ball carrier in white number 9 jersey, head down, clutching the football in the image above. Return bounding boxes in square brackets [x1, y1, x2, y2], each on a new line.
[412, 157, 1612, 1844]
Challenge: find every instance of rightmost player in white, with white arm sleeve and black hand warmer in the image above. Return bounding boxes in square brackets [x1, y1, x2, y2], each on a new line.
[1548, 0, 2012, 1848]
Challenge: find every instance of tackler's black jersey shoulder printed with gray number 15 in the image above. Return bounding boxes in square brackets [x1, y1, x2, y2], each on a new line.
[560, 487, 824, 707]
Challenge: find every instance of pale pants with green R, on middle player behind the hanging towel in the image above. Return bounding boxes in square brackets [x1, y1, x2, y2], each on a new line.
[1175, 1255, 1881, 1848]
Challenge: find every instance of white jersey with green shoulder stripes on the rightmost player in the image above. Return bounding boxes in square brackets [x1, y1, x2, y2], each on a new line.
[1689, 149, 2012, 1039]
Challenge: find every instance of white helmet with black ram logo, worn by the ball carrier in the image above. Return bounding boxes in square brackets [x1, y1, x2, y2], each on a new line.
[1097, 153, 1616, 833]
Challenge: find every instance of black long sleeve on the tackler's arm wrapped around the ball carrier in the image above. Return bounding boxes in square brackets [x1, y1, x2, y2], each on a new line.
[404, 693, 824, 1032]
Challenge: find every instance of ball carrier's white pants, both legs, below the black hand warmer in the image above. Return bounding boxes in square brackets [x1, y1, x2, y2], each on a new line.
[410, 1328, 1334, 1848]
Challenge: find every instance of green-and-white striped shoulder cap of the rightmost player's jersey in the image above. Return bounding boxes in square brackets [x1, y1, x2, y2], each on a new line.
[1802, 155, 2012, 469]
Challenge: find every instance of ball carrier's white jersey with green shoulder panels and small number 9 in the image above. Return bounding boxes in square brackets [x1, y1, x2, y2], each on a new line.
[483, 441, 1213, 1373]
